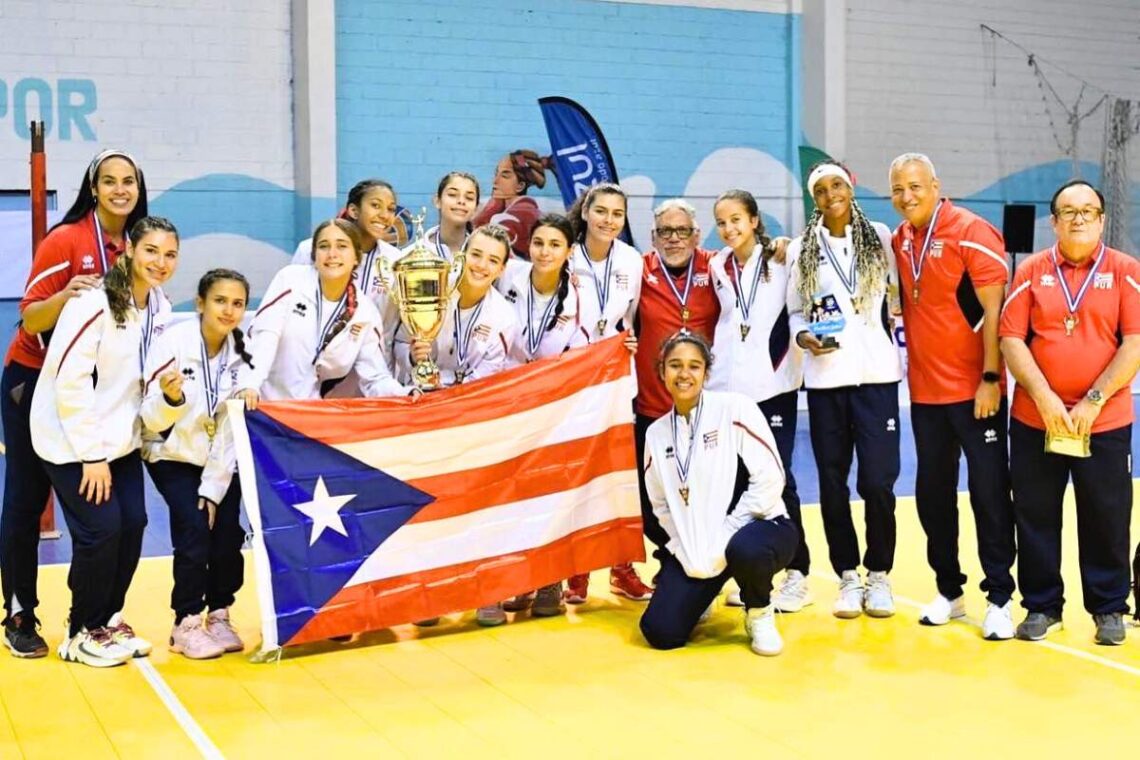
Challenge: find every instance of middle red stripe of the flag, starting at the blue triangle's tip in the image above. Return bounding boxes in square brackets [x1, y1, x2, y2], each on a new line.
[408, 425, 637, 524]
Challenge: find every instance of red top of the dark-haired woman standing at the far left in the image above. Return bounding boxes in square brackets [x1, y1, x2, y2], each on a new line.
[5, 211, 123, 369]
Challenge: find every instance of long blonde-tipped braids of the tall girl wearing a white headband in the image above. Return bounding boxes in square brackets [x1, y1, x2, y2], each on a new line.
[799, 161, 889, 314]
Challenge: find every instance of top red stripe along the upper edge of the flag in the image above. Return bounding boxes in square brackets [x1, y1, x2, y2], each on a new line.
[251, 335, 629, 446]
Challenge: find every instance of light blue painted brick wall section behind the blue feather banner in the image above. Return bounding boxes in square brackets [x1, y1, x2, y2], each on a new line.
[336, 0, 799, 243]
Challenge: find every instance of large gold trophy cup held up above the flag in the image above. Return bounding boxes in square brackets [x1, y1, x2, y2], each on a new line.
[377, 209, 464, 391]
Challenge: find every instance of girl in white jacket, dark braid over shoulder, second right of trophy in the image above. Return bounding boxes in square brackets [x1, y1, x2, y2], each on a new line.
[496, 214, 589, 618]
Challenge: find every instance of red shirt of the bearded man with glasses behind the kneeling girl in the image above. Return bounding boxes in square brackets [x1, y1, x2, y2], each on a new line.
[635, 248, 720, 418]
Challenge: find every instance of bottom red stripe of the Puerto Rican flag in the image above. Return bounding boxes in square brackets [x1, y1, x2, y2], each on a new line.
[282, 517, 645, 646]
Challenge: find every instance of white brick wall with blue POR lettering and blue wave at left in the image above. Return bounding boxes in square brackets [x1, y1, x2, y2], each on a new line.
[0, 0, 295, 299]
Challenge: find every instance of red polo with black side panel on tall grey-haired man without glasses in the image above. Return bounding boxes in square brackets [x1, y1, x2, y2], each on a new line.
[891, 198, 1009, 403]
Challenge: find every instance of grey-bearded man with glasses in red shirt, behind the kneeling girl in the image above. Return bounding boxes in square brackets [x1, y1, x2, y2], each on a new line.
[634, 198, 720, 562]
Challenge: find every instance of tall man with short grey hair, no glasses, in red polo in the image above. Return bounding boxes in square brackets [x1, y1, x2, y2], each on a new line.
[890, 153, 1016, 640]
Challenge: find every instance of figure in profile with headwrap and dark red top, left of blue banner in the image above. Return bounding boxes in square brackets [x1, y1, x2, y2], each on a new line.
[471, 149, 553, 259]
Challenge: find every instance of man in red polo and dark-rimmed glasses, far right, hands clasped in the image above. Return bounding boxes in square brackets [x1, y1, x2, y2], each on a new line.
[1001, 180, 1140, 645]
